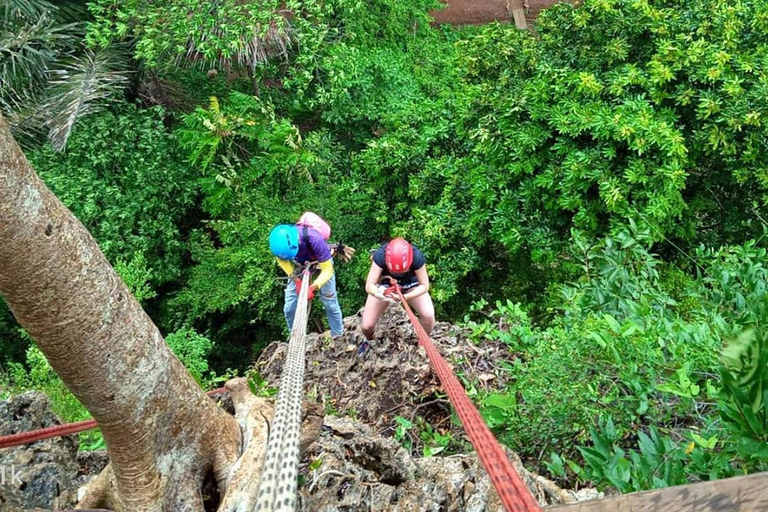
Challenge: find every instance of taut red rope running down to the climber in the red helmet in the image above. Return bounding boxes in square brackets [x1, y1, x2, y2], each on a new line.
[395, 285, 541, 512]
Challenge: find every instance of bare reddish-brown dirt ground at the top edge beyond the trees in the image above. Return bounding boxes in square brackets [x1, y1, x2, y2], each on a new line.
[432, 0, 559, 25]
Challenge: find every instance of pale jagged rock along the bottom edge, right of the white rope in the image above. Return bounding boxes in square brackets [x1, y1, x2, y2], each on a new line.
[299, 416, 575, 512]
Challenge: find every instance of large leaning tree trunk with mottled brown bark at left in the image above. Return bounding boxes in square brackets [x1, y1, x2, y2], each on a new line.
[0, 116, 241, 512]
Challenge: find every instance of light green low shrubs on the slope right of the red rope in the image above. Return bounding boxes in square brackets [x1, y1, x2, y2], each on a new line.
[470, 232, 768, 484]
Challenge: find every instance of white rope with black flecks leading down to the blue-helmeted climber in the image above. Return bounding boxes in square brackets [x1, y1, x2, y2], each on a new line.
[256, 269, 310, 512]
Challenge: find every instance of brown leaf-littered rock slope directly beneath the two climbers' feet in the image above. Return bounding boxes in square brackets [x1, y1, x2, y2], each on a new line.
[254, 307, 509, 444]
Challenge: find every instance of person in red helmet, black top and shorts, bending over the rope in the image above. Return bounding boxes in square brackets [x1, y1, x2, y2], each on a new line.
[360, 238, 435, 352]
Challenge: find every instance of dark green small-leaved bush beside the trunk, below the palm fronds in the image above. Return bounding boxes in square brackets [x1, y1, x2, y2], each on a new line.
[28, 106, 199, 288]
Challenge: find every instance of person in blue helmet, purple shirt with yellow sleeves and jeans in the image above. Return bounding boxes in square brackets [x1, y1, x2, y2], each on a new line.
[269, 224, 344, 337]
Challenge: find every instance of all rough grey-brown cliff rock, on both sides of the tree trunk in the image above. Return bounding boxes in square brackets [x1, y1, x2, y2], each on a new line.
[0, 308, 601, 512]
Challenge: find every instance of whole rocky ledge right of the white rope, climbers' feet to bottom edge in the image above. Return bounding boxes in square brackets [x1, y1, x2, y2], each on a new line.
[255, 308, 596, 512]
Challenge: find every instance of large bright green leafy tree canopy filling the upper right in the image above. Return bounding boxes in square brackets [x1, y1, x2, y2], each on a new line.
[450, 0, 765, 250]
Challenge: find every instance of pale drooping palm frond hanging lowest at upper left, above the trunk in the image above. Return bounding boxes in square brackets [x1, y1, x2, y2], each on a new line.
[45, 48, 128, 151]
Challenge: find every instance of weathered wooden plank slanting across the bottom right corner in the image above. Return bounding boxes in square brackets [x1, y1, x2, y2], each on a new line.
[545, 473, 768, 512]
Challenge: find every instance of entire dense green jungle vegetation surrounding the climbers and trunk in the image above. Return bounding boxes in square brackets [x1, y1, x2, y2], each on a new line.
[0, 0, 768, 492]
